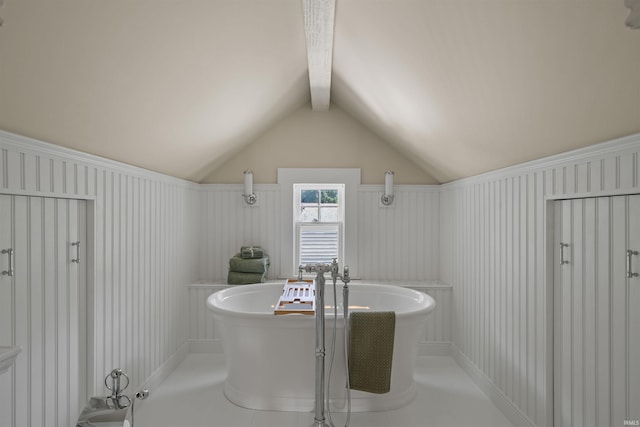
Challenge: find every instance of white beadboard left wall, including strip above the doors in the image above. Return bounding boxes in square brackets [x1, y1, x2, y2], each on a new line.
[0, 131, 200, 416]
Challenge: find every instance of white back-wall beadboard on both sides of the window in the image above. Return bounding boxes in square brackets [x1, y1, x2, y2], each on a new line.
[200, 185, 440, 282]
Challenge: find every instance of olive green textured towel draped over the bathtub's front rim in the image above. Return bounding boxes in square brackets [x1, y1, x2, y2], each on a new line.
[349, 311, 396, 394]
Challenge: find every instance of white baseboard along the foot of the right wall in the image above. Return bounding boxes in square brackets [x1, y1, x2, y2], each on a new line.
[451, 344, 536, 427]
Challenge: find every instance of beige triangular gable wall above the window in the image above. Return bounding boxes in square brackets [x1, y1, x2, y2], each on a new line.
[201, 105, 438, 184]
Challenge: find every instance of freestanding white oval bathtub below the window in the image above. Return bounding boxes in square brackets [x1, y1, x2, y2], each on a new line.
[207, 281, 435, 412]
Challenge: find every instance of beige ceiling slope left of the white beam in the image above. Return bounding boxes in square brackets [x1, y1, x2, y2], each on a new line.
[0, 0, 309, 181]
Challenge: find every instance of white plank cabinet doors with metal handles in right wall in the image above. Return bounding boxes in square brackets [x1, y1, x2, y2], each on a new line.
[554, 196, 640, 426]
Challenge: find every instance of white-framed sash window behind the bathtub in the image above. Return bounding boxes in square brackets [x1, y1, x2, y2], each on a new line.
[293, 184, 344, 265]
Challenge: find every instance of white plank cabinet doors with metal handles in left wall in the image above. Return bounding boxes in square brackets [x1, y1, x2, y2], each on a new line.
[0, 195, 86, 427]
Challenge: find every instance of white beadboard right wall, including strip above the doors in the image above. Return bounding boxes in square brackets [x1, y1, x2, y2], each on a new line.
[440, 135, 640, 426]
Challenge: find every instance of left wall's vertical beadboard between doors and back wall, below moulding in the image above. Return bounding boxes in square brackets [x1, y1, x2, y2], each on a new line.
[90, 176, 198, 393]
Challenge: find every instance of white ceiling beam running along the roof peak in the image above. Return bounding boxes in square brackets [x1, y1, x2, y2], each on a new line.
[302, 0, 336, 111]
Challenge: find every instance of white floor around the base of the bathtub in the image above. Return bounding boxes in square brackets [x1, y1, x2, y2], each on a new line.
[134, 353, 513, 427]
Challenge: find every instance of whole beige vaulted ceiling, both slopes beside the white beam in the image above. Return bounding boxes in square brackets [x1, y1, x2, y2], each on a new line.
[0, 0, 640, 182]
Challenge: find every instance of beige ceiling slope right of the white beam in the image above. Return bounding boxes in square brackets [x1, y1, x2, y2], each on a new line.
[331, 0, 640, 182]
